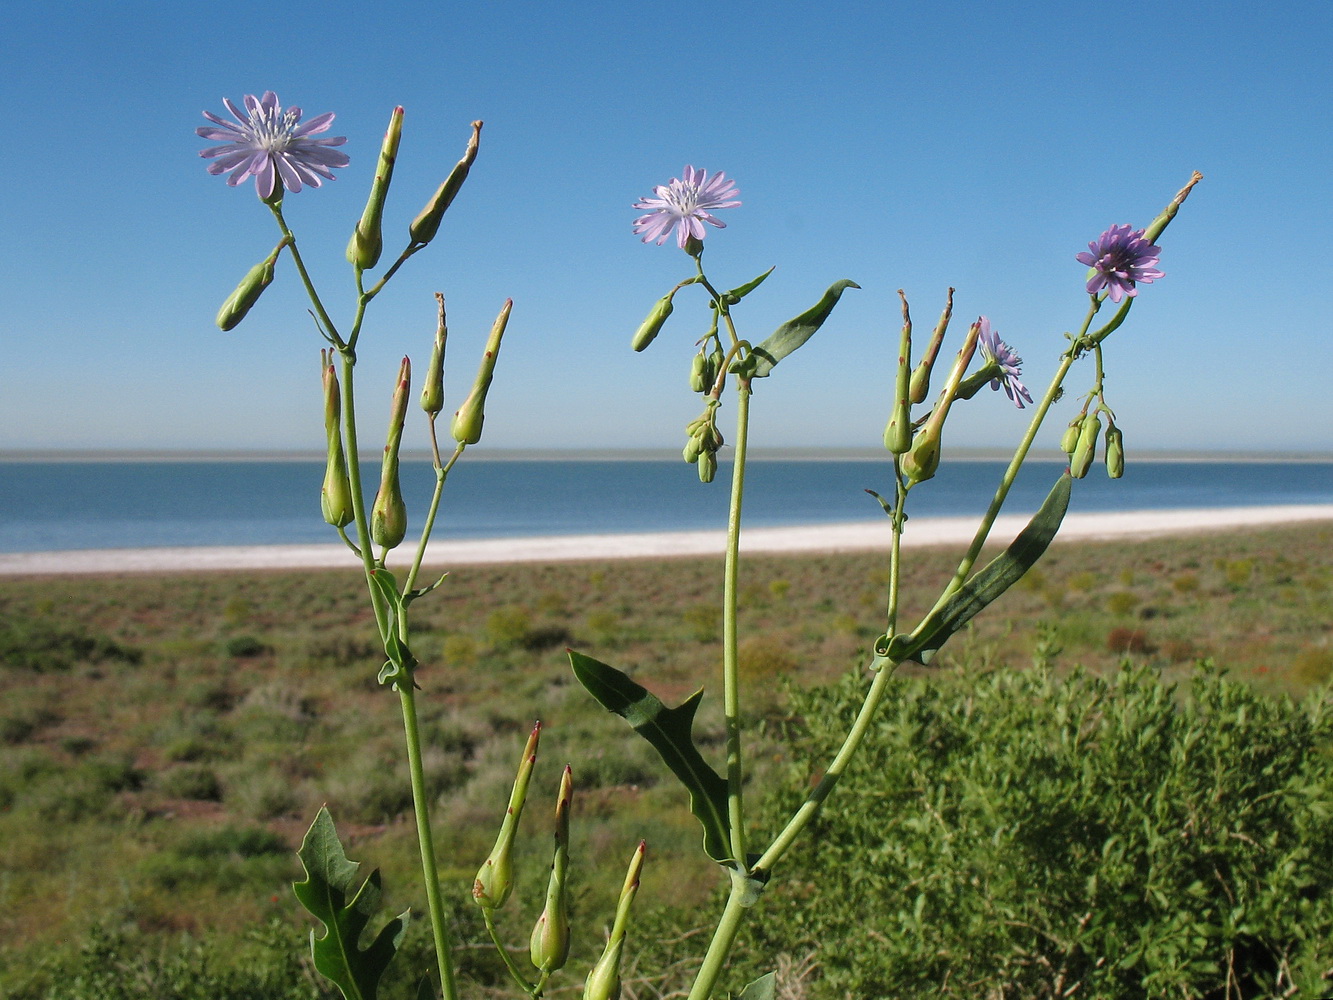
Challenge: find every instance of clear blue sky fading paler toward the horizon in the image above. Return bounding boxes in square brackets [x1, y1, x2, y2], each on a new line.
[0, 0, 1333, 457]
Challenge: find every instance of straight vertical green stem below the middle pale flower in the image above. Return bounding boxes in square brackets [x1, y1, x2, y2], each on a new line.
[722, 379, 750, 871]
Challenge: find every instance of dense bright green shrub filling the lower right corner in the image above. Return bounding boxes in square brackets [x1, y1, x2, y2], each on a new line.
[741, 667, 1333, 1000]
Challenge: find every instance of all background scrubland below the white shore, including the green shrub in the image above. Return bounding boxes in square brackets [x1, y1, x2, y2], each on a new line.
[0, 525, 1333, 1000]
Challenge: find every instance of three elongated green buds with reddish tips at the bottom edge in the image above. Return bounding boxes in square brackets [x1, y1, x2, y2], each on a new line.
[472, 723, 647, 1000]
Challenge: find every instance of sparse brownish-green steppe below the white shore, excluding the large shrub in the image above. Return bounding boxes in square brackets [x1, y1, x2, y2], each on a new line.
[0, 525, 1333, 1000]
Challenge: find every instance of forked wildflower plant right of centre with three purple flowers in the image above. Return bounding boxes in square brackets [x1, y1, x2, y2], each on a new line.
[571, 167, 1201, 1000]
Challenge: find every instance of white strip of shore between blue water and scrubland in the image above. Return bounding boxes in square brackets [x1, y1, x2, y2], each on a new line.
[0, 504, 1333, 576]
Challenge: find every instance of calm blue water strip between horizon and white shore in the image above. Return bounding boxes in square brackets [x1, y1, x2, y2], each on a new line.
[0, 459, 1333, 552]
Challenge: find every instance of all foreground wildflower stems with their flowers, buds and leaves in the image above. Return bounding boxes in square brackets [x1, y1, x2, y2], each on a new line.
[199, 92, 1200, 1000]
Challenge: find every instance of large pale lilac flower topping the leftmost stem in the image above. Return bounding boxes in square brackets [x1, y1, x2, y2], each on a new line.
[195, 91, 348, 199]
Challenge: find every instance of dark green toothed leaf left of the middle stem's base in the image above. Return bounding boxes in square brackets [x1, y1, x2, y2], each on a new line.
[569, 649, 732, 864]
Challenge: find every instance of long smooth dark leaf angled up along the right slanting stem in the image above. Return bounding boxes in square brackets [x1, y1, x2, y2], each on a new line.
[889, 472, 1073, 664]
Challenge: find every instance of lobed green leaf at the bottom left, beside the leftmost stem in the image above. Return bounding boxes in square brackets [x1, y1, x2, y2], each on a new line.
[292, 808, 408, 1000]
